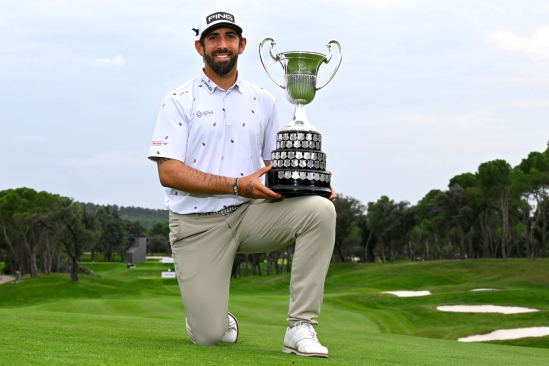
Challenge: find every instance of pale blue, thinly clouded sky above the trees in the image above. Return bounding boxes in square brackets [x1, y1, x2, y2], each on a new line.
[0, 0, 549, 208]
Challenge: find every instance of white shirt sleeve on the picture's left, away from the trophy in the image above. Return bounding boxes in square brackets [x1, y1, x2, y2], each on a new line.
[149, 97, 190, 163]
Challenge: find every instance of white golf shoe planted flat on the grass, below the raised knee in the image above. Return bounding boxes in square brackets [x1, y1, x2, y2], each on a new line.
[282, 322, 328, 357]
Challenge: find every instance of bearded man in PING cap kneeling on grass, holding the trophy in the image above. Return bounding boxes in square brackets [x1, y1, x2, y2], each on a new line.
[149, 9, 336, 357]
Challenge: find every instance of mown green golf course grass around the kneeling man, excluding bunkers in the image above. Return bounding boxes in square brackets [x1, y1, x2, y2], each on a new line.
[0, 260, 549, 366]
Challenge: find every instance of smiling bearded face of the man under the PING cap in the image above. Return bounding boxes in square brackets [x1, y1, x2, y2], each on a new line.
[197, 28, 246, 75]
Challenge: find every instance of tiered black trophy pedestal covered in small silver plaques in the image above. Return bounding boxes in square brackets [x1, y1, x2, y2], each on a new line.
[266, 130, 332, 197]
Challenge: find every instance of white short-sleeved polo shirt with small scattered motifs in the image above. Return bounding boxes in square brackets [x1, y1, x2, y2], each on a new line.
[149, 71, 280, 214]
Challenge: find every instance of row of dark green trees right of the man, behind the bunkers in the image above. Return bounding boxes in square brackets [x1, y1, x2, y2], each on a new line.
[334, 142, 549, 262]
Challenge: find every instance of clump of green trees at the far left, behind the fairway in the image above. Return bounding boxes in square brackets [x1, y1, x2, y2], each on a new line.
[0, 188, 150, 281]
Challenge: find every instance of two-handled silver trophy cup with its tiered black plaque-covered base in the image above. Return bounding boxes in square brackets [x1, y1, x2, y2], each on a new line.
[259, 37, 343, 197]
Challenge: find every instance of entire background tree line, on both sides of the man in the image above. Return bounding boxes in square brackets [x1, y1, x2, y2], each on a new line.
[0, 145, 549, 281]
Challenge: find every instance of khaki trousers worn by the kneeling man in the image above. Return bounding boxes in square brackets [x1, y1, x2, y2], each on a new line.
[170, 196, 336, 345]
